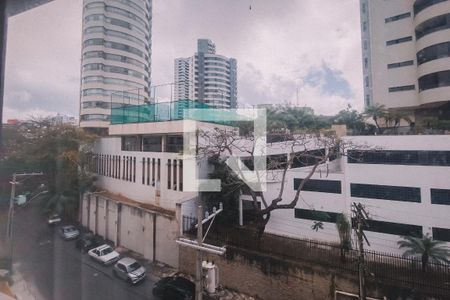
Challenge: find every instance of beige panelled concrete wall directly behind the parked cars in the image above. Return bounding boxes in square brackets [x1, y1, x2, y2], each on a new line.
[81, 194, 180, 267]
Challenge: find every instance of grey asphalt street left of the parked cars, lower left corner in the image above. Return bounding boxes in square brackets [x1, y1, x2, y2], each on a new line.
[9, 201, 157, 300]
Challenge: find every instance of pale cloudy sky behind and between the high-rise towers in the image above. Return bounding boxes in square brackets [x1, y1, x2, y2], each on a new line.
[4, 0, 363, 121]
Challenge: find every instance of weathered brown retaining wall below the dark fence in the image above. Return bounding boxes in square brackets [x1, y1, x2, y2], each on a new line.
[180, 247, 362, 300]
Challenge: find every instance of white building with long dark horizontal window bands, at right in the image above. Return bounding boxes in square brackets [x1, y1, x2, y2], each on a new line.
[248, 135, 450, 254]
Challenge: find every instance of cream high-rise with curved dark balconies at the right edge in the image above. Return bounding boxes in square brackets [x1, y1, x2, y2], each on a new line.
[360, 0, 450, 122]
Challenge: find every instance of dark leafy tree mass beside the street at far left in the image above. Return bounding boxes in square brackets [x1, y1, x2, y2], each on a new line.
[0, 119, 95, 215]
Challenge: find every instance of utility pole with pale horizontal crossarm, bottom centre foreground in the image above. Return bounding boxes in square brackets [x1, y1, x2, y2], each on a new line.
[176, 203, 226, 300]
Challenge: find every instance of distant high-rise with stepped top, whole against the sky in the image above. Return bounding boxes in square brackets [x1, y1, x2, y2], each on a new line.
[174, 39, 237, 108]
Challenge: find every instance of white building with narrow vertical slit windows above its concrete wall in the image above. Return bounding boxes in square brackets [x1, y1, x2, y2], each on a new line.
[80, 116, 234, 267]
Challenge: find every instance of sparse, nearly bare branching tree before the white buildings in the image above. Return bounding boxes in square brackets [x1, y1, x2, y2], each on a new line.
[198, 128, 353, 238]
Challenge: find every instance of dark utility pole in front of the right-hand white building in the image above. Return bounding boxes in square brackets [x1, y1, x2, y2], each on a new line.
[352, 203, 370, 300]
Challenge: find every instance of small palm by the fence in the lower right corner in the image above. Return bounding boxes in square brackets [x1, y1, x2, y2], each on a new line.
[397, 234, 450, 271]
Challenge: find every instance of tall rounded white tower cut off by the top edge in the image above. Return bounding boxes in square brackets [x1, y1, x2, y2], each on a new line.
[80, 0, 152, 128]
